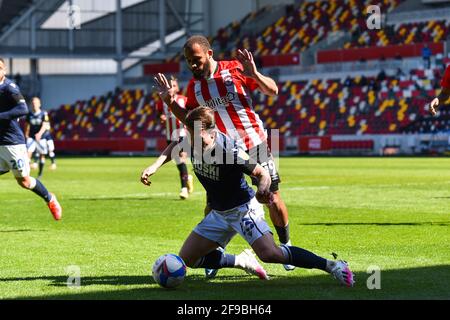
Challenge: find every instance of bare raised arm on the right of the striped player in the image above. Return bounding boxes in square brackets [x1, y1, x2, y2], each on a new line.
[236, 49, 278, 96]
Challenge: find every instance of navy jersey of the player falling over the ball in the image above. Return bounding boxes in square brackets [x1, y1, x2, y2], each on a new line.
[191, 132, 256, 211]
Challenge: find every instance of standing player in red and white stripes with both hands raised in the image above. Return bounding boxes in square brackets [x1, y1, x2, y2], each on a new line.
[155, 36, 293, 270]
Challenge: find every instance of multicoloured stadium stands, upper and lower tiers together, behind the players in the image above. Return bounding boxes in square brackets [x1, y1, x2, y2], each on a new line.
[19, 0, 450, 153]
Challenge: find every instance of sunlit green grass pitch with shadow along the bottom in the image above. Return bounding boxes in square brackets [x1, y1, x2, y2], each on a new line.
[0, 158, 450, 299]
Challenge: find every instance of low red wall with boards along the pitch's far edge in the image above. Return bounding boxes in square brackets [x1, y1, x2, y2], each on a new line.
[56, 133, 450, 156]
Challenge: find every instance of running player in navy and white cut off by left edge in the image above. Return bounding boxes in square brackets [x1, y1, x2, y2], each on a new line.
[0, 58, 62, 220]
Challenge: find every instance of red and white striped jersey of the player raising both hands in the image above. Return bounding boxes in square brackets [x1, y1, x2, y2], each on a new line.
[186, 60, 267, 150]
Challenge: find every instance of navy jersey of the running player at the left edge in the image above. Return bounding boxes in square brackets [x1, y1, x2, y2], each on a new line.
[0, 78, 28, 145]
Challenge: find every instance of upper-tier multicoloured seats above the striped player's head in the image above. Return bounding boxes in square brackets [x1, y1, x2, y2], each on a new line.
[167, 0, 404, 65]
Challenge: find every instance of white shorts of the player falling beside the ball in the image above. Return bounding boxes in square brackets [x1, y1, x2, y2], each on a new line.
[194, 197, 271, 247]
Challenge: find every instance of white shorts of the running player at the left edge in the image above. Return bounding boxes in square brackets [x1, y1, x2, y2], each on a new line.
[0, 144, 30, 178]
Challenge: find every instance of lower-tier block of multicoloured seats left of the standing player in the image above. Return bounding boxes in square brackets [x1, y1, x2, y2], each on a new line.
[50, 89, 163, 140]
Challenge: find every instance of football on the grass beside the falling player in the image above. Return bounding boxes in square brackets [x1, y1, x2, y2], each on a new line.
[152, 253, 186, 288]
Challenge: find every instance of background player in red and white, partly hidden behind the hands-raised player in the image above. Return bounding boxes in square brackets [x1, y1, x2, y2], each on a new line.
[157, 77, 194, 200]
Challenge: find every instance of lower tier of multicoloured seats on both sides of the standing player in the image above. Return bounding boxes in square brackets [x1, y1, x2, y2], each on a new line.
[50, 65, 449, 147]
